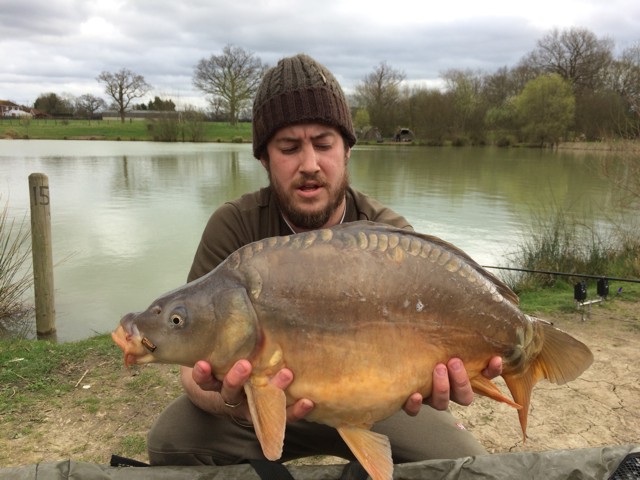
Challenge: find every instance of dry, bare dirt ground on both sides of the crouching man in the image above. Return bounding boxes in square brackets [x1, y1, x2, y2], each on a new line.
[0, 301, 640, 466]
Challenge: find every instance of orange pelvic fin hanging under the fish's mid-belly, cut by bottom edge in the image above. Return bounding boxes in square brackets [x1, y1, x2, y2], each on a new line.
[338, 426, 393, 480]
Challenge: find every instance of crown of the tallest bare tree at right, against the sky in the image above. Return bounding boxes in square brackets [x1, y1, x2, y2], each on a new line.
[528, 27, 613, 92]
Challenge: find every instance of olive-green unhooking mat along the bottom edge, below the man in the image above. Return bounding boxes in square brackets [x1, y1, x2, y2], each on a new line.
[0, 445, 640, 480]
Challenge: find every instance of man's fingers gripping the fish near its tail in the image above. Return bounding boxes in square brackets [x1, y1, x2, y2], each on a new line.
[403, 357, 502, 416]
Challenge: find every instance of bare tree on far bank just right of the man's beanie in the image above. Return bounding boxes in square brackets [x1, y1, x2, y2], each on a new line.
[355, 62, 406, 134]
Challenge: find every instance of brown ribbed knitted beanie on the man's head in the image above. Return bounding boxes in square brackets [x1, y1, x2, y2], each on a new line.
[253, 54, 356, 159]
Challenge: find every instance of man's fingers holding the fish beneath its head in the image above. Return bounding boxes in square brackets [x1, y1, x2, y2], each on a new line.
[192, 360, 314, 422]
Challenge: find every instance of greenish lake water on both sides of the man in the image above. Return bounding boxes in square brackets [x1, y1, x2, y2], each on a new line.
[0, 140, 637, 341]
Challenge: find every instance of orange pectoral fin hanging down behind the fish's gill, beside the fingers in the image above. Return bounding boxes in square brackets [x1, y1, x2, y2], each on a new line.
[244, 376, 287, 460]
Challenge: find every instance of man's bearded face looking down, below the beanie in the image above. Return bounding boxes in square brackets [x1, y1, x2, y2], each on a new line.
[261, 123, 351, 230]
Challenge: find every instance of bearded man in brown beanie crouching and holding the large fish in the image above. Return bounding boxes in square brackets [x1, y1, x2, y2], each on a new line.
[148, 55, 501, 465]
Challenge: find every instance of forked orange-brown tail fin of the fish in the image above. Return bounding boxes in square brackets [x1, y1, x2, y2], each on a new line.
[502, 319, 593, 439]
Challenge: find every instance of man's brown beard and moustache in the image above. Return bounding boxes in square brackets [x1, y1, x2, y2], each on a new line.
[267, 169, 349, 230]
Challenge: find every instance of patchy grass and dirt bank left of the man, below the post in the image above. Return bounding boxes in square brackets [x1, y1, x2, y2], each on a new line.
[0, 335, 181, 465]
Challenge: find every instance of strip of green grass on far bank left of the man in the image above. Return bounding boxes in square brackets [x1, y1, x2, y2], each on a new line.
[0, 119, 252, 143]
